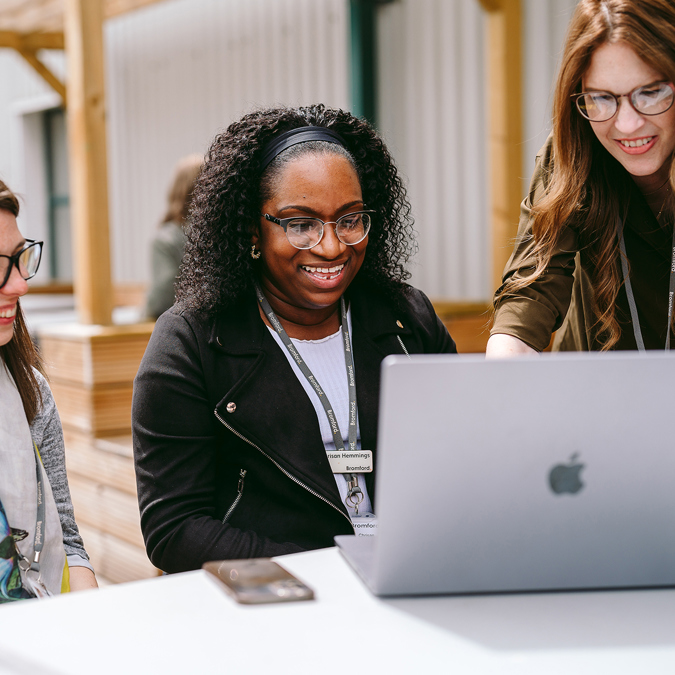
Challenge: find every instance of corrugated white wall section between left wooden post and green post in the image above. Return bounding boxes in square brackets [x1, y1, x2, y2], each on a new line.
[105, 0, 349, 281]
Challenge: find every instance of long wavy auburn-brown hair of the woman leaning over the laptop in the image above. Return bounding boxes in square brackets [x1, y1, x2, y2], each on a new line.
[498, 0, 675, 350]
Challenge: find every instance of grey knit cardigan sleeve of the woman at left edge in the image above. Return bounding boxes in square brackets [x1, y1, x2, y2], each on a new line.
[30, 371, 94, 572]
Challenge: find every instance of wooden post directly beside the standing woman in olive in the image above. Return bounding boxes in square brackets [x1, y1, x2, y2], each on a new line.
[480, 0, 523, 288]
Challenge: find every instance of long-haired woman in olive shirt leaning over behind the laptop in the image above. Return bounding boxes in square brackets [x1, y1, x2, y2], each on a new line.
[488, 0, 675, 356]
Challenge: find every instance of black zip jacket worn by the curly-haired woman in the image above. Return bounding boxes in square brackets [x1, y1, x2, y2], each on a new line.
[132, 289, 456, 572]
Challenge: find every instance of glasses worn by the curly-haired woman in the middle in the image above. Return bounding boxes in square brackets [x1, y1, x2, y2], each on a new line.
[263, 210, 375, 249]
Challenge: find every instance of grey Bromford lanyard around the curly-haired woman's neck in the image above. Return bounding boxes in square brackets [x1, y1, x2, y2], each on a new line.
[255, 283, 370, 513]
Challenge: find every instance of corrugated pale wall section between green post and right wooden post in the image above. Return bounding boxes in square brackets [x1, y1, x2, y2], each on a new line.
[378, 0, 490, 300]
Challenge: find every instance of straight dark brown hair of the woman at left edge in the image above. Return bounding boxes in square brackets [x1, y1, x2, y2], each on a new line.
[0, 180, 42, 423]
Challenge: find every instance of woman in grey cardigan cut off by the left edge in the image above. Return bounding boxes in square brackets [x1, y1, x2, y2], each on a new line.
[0, 181, 97, 603]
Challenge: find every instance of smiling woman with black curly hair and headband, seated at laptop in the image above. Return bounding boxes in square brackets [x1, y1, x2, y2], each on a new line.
[133, 105, 455, 572]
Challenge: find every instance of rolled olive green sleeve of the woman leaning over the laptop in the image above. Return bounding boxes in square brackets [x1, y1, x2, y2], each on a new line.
[490, 137, 578, 351]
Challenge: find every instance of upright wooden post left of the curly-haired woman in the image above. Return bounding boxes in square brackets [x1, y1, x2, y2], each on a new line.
[65, 0, 112, 325]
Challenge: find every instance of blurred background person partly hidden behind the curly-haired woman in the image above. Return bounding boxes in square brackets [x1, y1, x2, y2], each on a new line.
[145, 155, 204, 319]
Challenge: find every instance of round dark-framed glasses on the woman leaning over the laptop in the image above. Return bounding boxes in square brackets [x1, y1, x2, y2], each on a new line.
[571, 80, 675, 122]
